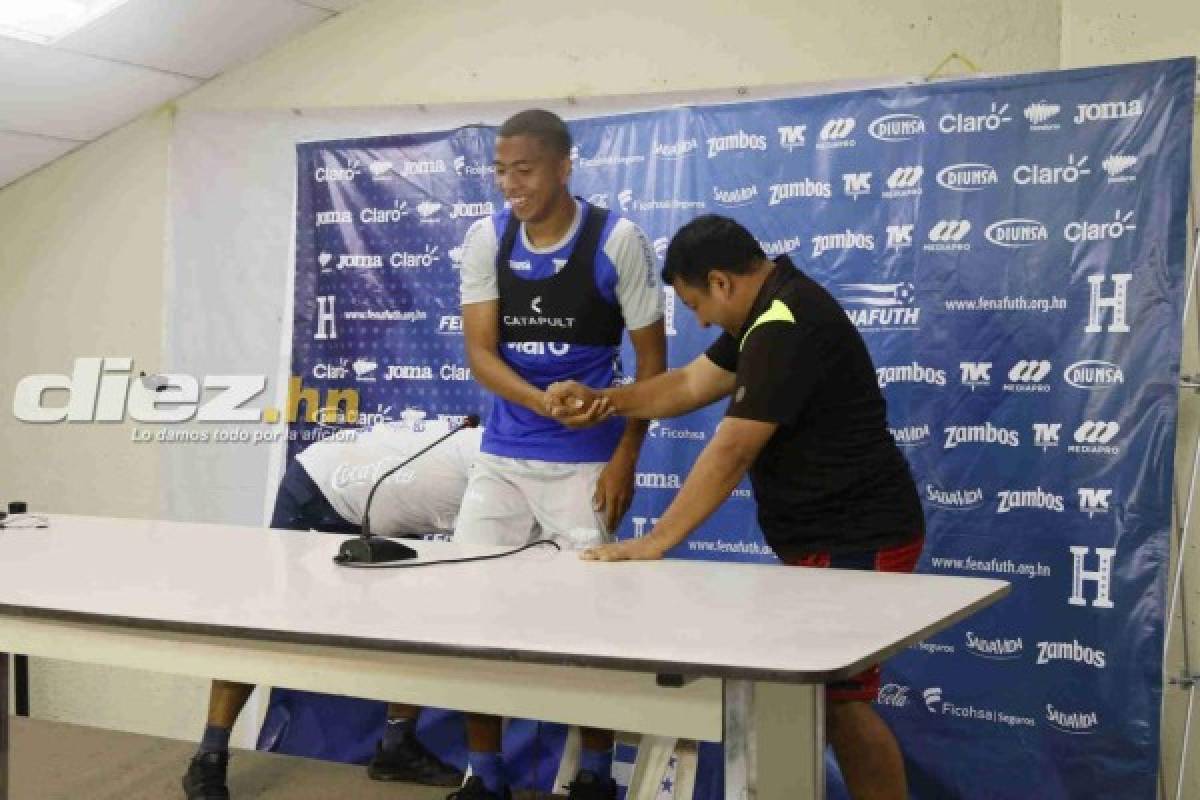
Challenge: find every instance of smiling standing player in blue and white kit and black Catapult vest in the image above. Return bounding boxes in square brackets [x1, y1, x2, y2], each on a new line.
[450, 110, 666, 800]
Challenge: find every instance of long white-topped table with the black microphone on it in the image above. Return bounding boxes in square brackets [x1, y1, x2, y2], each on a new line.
[0, 515, 1008, 800]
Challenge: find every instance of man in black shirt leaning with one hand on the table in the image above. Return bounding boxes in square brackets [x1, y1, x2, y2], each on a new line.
[550, 215, 924, 799]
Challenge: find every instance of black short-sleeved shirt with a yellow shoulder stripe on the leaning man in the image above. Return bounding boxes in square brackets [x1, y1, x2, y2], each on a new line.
[706, 255, 924, 557]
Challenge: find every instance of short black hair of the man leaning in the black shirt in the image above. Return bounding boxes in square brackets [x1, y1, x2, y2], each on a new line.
[662, 213, 767, 287]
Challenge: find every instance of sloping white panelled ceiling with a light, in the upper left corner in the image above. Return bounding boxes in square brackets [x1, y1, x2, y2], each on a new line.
[0, 0, 364, 187]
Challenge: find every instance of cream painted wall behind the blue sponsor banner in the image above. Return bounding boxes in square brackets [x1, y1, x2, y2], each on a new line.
[0, 0, 1200, 796]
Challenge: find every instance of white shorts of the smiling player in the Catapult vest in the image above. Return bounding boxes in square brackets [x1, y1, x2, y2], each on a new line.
[454, 453, 611, 549]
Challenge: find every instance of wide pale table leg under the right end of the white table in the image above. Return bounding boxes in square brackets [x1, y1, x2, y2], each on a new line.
[725, 680, 824, 800]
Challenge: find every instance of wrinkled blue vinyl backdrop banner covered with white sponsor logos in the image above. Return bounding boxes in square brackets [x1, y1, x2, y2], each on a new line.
[270, 59, 1195, 799]
